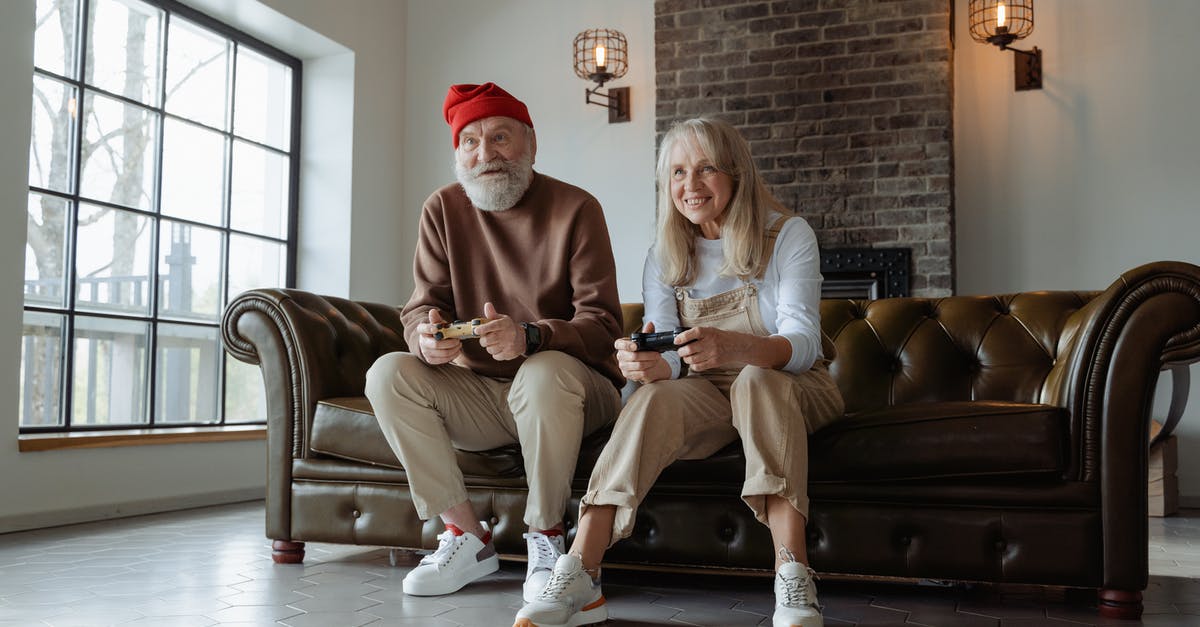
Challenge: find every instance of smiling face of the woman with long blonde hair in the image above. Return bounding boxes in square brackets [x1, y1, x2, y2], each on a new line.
[668, 142, 733, 239]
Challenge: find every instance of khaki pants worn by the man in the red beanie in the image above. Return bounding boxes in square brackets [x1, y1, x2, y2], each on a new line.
[366, 351, 620, 529]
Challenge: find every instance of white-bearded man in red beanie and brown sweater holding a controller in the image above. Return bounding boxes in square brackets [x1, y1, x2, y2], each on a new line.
[366, 83, 624, 601]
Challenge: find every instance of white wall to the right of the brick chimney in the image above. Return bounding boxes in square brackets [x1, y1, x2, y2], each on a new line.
[954, 0, 1200, 497]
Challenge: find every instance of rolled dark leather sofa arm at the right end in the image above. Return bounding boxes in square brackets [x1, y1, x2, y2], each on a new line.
[1044, 262, 1200, 595]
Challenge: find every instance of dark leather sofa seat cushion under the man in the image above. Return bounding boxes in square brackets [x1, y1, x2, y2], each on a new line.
[308, 396, 524, 477]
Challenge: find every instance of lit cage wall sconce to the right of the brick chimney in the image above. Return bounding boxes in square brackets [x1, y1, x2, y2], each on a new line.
[967, 0, 1042, 91]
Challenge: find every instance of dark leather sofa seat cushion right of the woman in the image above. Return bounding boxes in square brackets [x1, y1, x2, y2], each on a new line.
[809, 401, 1069, 482]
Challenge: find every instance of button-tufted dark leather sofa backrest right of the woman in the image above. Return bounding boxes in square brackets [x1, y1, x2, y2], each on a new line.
[821, 292, 1094, 413]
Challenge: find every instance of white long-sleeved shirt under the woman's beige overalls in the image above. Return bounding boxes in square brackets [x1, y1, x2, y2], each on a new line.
[642, 213, 822, 378]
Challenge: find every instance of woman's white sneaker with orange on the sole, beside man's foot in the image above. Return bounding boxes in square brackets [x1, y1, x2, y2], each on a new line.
[512, 554, 608, 627]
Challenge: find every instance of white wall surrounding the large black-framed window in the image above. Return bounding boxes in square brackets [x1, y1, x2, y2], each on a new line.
[0, 0, 412, 532]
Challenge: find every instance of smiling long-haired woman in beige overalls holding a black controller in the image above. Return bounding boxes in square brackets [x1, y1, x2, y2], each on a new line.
[516, 113, 844, 627]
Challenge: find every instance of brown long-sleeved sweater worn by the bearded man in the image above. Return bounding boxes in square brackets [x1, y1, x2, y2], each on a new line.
[402, 173, 624, 387]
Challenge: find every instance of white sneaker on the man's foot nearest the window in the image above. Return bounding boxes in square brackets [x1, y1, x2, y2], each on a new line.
[404, 525, 500, 597]
